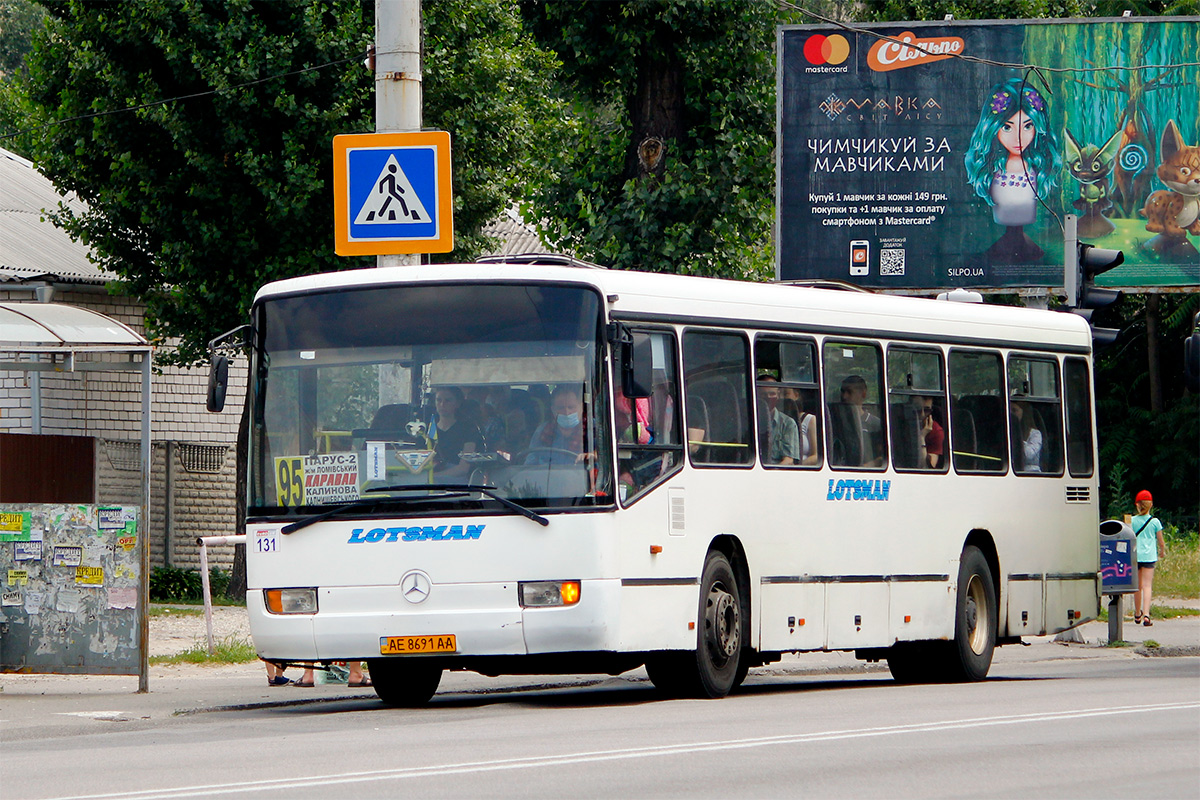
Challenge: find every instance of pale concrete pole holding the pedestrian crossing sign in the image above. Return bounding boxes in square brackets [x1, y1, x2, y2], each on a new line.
[374, 0, 421, 266]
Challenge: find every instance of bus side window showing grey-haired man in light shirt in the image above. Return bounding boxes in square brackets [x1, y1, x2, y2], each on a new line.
[755, 338, 821, 467]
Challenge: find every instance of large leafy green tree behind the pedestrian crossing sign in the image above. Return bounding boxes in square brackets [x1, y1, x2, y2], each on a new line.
[7, 0, 554, 363]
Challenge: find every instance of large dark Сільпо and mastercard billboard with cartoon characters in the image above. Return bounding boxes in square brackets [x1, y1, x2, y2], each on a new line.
[776, 18, 1200, 289]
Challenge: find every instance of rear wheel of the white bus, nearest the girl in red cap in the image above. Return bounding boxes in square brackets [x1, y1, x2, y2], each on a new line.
[946, 546, 997, 681]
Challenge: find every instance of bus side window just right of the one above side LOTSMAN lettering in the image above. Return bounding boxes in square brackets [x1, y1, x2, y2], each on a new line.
[888, 347, 948, 471]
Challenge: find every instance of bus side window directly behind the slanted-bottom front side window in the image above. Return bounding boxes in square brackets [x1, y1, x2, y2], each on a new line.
[683, 331, 754, 465]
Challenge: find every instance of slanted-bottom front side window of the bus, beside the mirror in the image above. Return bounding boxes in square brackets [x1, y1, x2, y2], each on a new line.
[613, 331, 683, 503]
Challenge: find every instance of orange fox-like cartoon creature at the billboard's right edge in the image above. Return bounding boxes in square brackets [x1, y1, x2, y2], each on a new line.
[1139, 120, 1200, 255]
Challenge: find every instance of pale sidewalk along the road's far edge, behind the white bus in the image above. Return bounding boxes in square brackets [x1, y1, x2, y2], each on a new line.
[0, 602, 1200, 741]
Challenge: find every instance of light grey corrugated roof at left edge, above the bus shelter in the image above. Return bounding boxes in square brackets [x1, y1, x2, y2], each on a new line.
[0, 149, 110, 285]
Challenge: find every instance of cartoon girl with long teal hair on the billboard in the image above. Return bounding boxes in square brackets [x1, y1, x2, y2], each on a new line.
[964, 78, 1062, 264]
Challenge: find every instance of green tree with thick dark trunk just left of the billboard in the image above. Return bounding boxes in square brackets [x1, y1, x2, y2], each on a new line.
[523, 0, 796, 278]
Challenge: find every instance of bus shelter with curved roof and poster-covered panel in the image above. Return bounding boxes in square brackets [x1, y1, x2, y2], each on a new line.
[0, 302, 152, 692]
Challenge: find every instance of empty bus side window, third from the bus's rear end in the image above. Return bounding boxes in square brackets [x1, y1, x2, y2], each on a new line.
[950, 350, 1008, 473]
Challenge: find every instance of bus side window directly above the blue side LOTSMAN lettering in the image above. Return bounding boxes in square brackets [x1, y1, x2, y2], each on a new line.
[822, 342, 888, 469]
